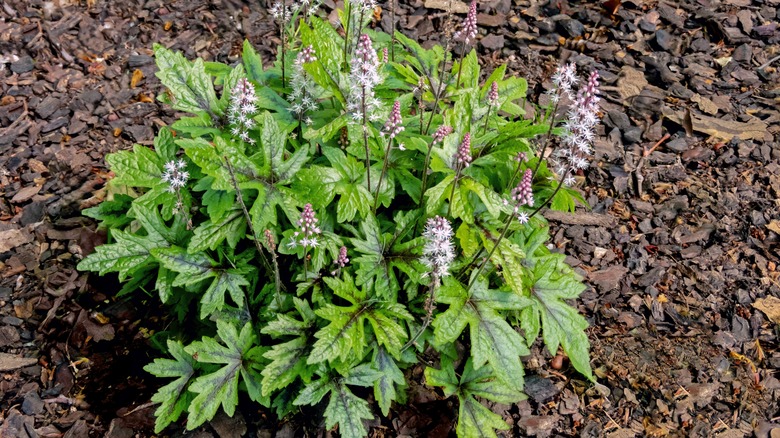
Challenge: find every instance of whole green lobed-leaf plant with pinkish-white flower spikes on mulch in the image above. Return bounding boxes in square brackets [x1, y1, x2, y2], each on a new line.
[79, 1, 598, 437]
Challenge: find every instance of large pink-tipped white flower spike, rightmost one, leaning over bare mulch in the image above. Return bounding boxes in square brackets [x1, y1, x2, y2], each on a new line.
[557, 71, 599, 185]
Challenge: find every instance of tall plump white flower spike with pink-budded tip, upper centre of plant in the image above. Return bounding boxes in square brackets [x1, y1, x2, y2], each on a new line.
[347, 34, 382, 122]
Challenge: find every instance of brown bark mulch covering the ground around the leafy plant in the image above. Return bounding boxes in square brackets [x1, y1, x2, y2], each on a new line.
[0, 0, 780, 438]
